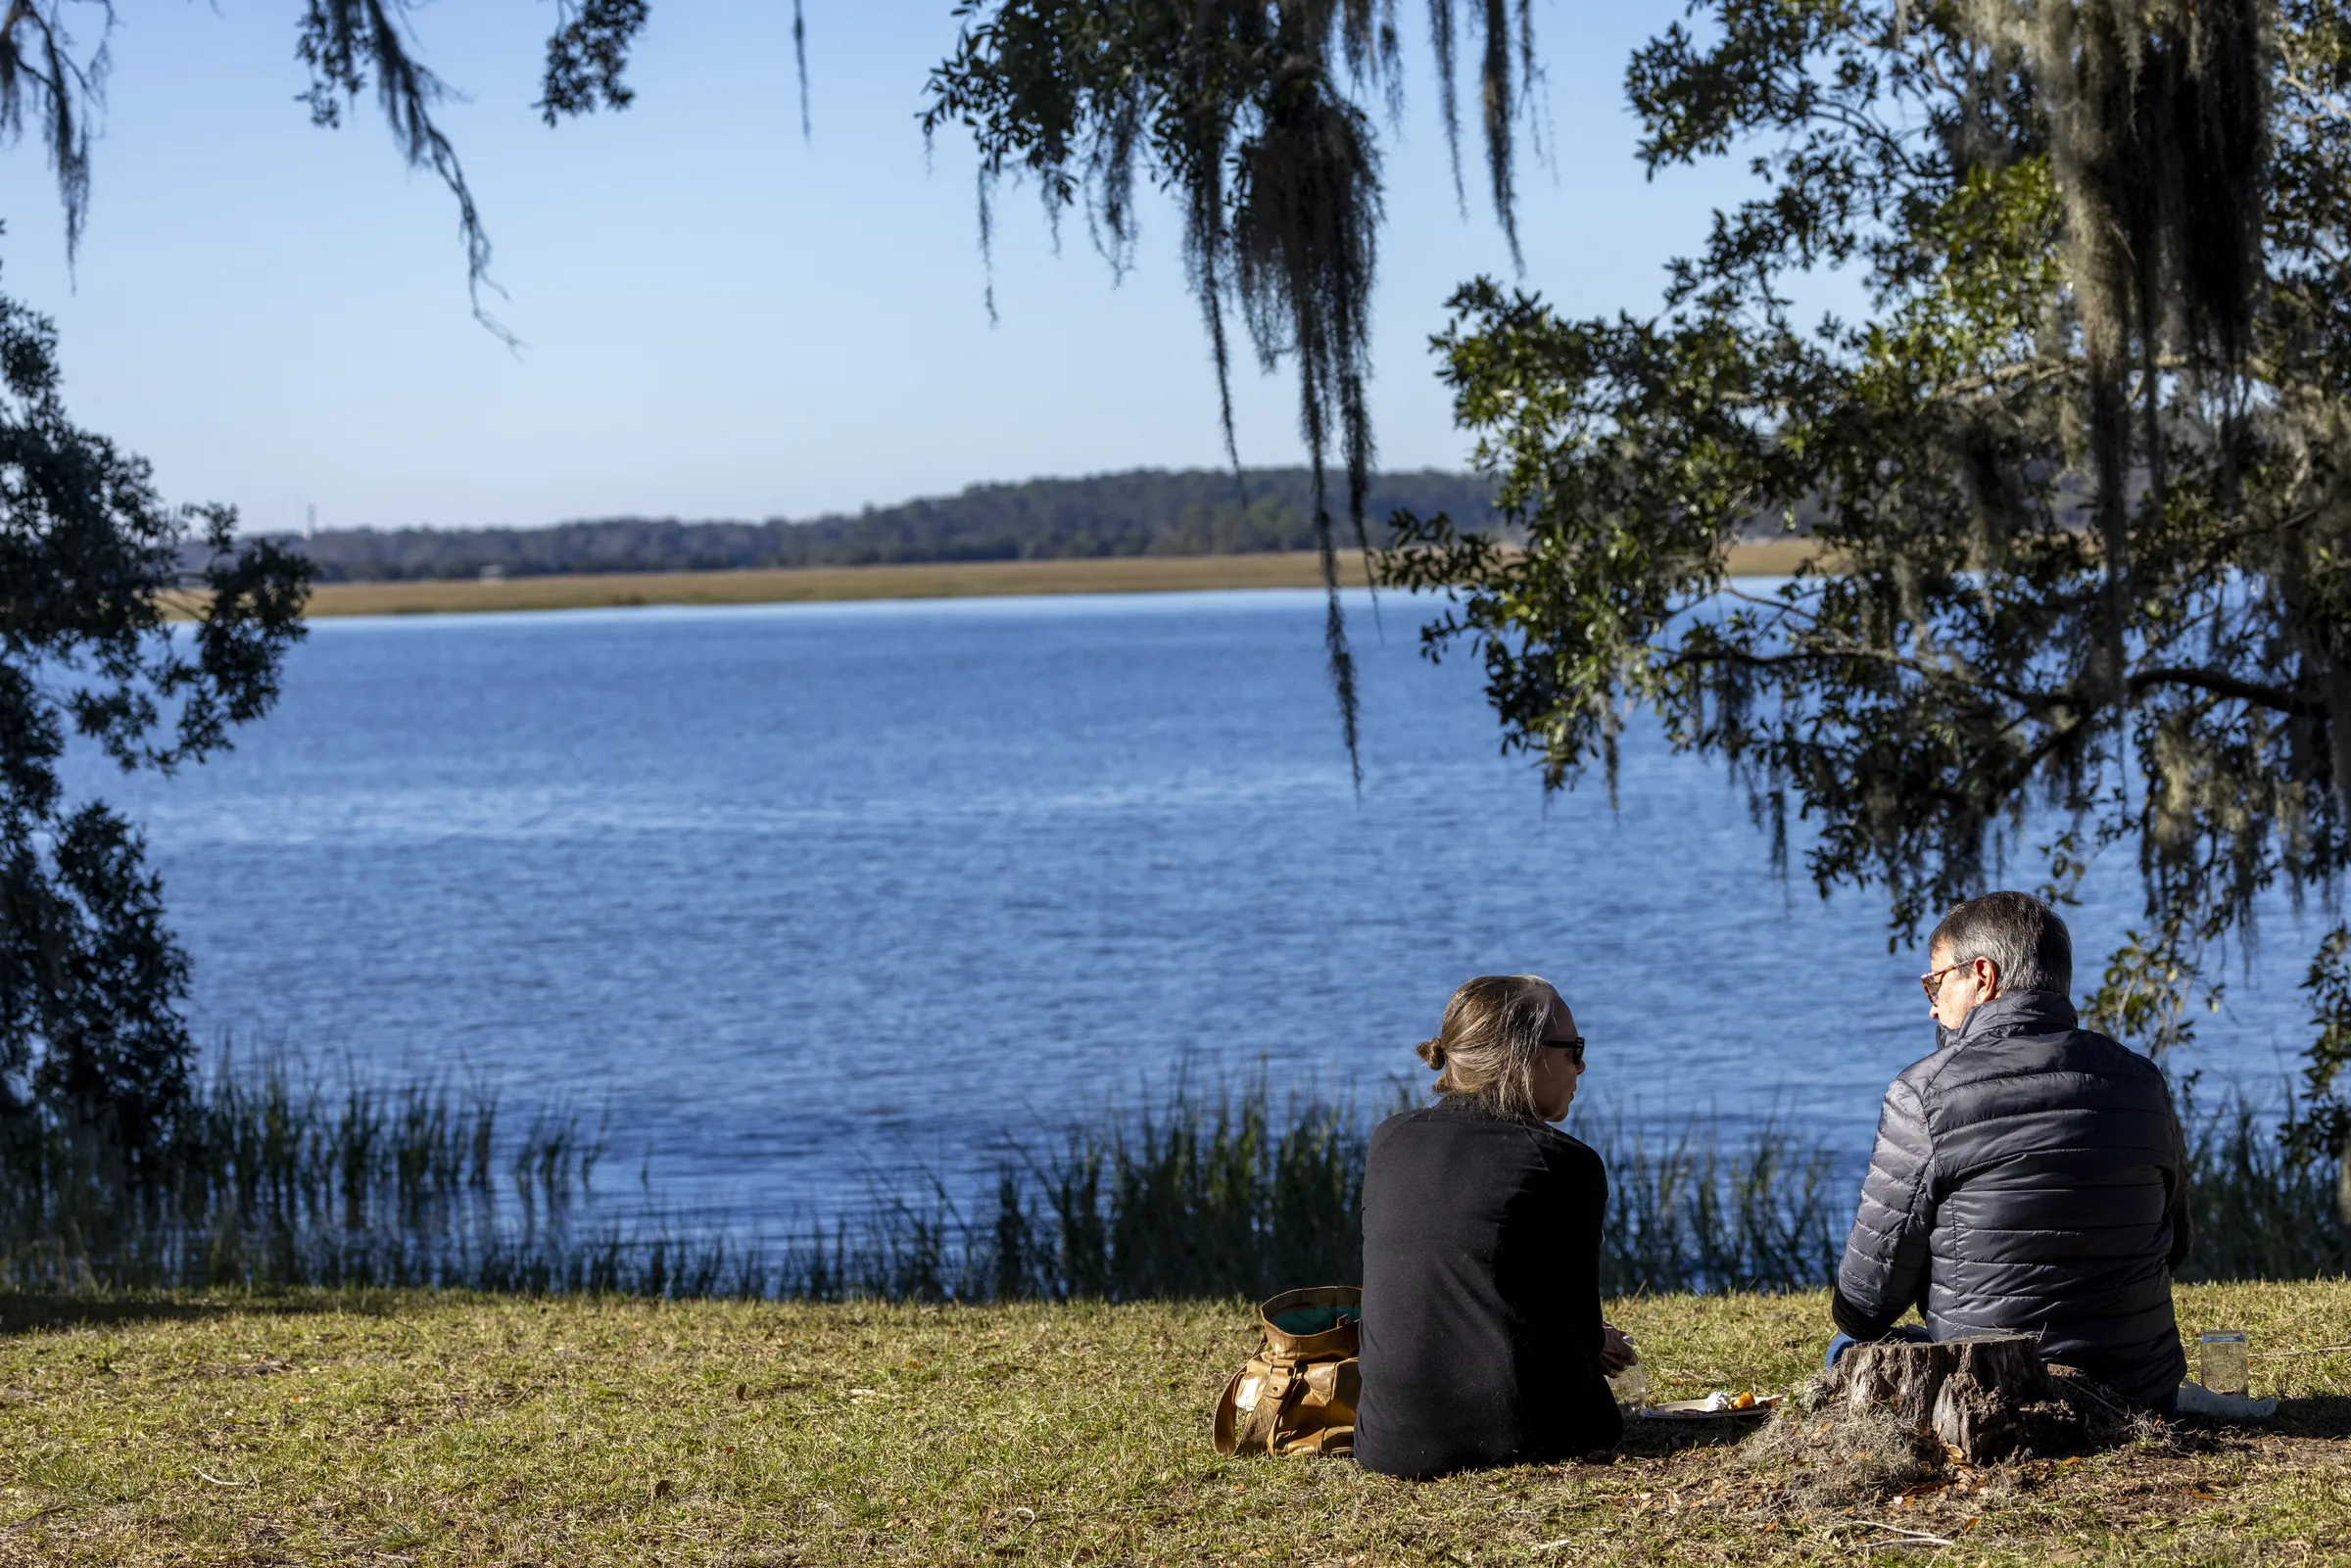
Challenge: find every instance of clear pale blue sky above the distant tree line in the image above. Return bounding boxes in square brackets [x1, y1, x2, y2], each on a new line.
[0, 0, 1777, 529]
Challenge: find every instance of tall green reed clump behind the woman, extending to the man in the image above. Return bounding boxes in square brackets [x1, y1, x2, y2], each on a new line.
[781, 1081, 1852, 1300]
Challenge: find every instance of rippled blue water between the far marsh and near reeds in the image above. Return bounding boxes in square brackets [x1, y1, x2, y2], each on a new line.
[64, 593, 2309, 1222]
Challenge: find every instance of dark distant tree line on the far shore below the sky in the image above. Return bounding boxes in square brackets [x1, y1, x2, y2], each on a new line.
[270, 468, 1493, 583]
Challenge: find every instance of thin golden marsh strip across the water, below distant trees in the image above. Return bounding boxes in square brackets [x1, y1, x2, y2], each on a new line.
[178, 539, 1815, 618]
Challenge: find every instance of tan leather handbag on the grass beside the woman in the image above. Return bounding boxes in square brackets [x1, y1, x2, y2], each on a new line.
[1216, 1286, 1364, 1455]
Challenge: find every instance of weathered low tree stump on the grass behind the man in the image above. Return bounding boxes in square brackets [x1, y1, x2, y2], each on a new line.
[1832, 1333, 2050, 1464]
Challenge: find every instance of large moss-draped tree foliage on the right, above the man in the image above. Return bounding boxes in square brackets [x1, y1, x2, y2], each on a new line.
[1385, 0, 2351, 1131]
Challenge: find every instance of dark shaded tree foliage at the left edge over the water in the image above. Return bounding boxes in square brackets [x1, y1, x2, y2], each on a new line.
[0, 301, 308, 1150]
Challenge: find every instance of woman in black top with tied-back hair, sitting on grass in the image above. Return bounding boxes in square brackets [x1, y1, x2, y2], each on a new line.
[1354, 975, 1634, 1479]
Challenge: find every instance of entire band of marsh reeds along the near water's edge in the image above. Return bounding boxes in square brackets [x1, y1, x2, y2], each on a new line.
[0, 1061, 2344, 1303]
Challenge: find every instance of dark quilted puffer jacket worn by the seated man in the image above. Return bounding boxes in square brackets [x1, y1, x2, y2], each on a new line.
[1834, 992, 2188, 1405]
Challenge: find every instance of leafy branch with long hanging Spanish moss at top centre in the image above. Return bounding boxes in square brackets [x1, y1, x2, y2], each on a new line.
[922, 0, 1533, 785]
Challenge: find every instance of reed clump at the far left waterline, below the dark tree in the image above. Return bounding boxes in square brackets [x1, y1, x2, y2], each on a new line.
[0, 1061, 653, 1293]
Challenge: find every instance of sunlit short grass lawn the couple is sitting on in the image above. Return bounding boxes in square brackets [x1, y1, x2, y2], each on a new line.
[0, 1284, 2351, 1568]
